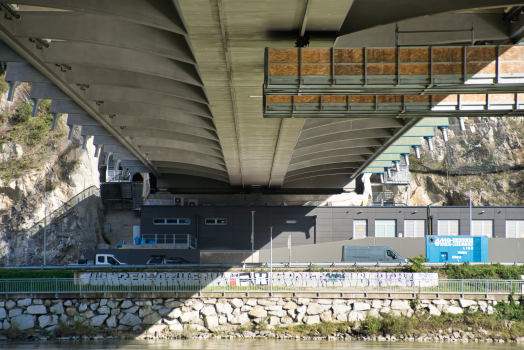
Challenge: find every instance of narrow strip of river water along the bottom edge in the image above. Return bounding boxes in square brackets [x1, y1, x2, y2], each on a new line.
[0, 340, 524, 350]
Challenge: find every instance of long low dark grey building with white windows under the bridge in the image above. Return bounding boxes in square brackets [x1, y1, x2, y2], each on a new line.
[141, 206, 524, 254]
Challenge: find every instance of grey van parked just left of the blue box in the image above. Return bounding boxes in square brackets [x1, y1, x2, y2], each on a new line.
[342, 245, 408, 263]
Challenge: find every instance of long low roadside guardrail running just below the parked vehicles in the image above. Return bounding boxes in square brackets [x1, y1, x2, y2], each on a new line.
[0, 262, 524, 270]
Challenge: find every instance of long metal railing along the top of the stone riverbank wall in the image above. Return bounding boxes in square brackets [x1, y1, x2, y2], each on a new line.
[0, 274, 524, 297]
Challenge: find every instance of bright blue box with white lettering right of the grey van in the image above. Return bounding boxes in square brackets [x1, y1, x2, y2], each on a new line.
[426, 236, 488, 263]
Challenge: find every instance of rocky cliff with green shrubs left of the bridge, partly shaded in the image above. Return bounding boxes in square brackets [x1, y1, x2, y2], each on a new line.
[0, 78, 103, 265]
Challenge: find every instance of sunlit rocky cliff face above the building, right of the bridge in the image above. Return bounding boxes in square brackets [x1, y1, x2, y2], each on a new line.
[395, 117, 524, 206]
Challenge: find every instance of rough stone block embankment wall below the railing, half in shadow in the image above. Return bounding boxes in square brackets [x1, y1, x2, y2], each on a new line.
[0, 298, 516, 339]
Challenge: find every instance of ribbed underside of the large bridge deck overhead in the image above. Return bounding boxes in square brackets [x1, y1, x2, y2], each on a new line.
[0, 0, 524, 193]
